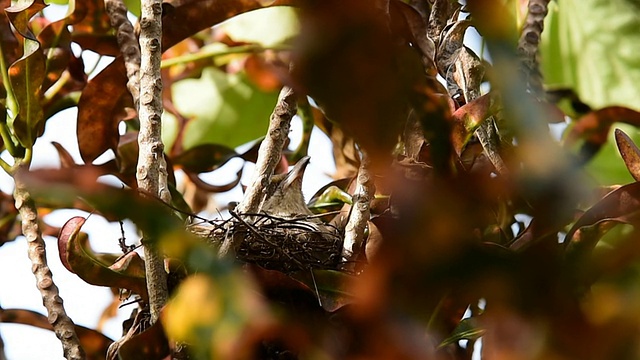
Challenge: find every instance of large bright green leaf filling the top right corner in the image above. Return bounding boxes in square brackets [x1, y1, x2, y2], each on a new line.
[540, 0, 640, 109]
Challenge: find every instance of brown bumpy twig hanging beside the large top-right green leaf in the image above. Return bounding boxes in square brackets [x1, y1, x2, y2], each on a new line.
[518, 0, 549, 99]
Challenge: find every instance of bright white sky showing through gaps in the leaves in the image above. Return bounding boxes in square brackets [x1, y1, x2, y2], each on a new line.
[0, 6, 492, 360]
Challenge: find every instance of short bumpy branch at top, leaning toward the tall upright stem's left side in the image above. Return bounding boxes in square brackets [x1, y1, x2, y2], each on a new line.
[104, 0, 140, 109]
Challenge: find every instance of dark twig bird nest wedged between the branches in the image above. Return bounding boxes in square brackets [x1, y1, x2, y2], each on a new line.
[191, 213, 343, 273]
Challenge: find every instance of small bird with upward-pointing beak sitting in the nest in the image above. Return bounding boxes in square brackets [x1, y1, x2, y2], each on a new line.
[262, 156, 313, 218]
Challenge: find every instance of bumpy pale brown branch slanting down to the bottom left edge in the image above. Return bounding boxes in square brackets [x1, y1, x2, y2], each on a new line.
[13, 169, 85, 360]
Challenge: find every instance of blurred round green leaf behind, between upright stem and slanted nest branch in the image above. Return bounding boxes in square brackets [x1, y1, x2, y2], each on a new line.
[172, 68, 277, 149]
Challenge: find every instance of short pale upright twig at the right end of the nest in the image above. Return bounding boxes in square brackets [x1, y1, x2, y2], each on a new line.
[342, 151, 376, 266]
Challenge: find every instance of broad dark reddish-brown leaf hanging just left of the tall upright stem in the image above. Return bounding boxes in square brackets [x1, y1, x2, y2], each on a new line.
[77, 57, 133, 164]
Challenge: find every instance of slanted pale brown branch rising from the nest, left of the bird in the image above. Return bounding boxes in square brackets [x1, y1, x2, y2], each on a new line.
[218, 86, 298, 257]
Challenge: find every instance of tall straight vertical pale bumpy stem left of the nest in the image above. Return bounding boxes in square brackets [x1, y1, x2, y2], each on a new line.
[136, 0, 171, 323]
